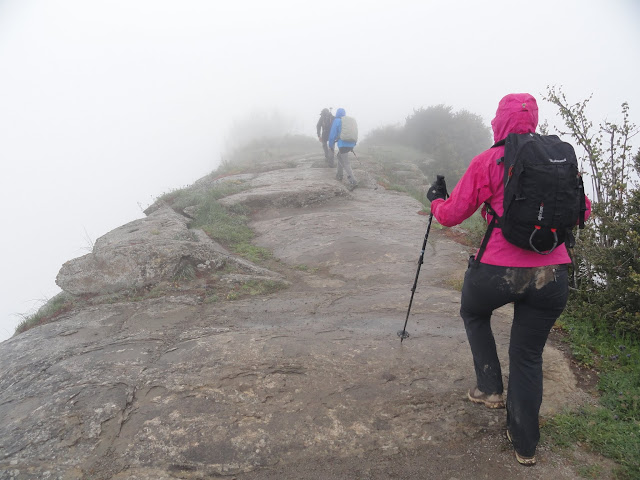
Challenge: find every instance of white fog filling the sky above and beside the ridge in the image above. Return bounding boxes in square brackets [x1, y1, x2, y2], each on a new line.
[0, 0, 640, 340]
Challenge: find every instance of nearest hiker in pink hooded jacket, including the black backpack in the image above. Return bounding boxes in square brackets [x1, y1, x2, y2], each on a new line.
[427, 93, 591, 465]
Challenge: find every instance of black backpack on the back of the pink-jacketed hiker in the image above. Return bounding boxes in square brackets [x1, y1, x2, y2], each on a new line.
[476, 133, 586, 262]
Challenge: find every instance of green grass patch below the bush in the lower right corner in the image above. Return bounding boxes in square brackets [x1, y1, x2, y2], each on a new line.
[542, 315, 640, 479]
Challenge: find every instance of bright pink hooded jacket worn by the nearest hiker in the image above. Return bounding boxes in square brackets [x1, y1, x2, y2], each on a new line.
[431, 93, 591, 267]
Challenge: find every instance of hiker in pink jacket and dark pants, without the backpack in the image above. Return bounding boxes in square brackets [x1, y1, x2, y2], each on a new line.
[427, 93, 591, 465]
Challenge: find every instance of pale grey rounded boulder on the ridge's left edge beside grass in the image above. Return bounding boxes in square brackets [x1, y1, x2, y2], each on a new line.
[56, 207, 280, 295]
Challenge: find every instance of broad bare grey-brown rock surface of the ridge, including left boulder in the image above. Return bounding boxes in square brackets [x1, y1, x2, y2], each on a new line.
[0, 151, 608, 480]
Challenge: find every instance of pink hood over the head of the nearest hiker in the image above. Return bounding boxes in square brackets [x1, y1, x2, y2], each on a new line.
[491, 93, 538, 142]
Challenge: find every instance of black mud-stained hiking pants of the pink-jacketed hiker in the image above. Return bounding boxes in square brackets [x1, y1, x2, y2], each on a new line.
[460, 262, 569, 457]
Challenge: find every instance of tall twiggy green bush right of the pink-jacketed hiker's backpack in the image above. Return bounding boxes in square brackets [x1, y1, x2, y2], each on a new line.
[544, 87, 640, 334]
